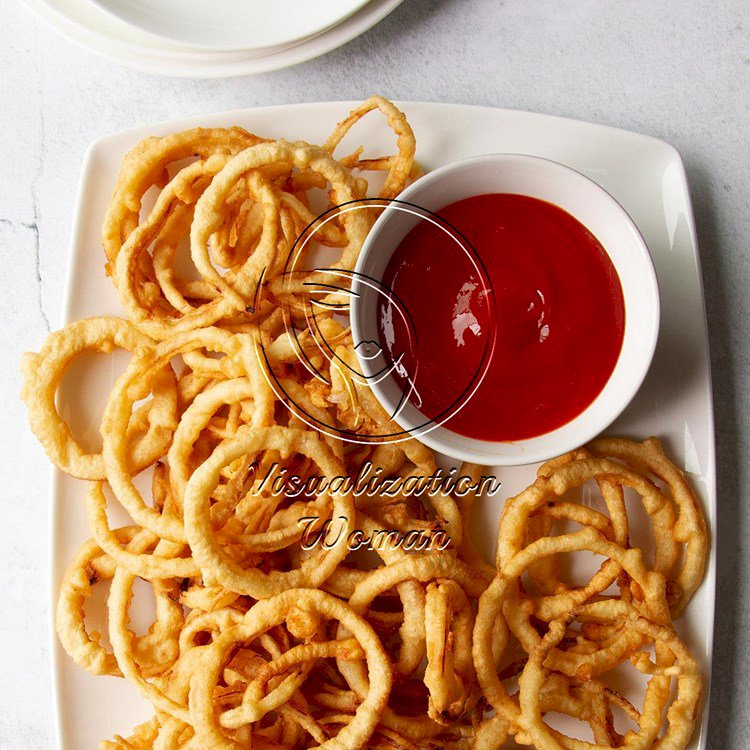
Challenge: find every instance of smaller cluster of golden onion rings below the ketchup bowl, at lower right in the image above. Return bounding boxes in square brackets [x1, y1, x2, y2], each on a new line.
[472, 437, 708, 750]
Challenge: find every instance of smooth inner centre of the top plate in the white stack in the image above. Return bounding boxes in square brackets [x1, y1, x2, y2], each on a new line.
[90, 0, 367, 50]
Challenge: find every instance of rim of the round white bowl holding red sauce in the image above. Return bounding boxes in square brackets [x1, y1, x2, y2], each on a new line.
[350, 152, 661, 466]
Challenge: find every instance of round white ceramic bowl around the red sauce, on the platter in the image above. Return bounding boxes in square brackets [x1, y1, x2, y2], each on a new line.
[351, 154, 659, 466]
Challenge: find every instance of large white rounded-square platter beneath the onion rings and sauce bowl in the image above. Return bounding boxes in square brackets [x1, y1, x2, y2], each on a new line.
[52, 102, 716, 750]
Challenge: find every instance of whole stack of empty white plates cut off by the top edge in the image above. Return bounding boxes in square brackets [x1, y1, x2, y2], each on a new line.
[26, 0, 402, 78]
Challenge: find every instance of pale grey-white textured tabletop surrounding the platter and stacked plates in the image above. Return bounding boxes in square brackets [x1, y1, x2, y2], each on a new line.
[0, 0, 750, 750]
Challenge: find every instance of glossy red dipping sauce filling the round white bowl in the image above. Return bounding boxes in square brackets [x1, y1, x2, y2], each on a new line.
[378, 194, 625, 441]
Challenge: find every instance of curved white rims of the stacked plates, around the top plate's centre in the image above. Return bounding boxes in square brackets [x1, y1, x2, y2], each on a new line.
[24, 0, 403, 78]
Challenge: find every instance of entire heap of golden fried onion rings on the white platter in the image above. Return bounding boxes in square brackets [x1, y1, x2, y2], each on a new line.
[22, 96, 708, 750]
